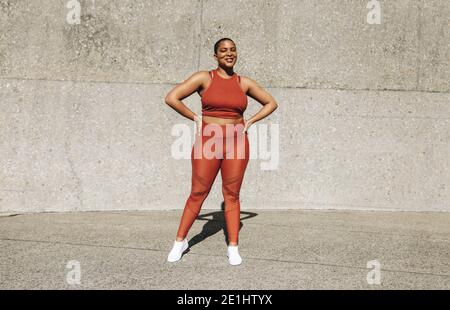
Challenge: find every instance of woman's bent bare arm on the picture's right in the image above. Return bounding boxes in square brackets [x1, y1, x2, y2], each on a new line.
[241, 77, 278, 131]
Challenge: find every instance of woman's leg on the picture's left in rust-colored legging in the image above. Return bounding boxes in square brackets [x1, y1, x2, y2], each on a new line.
[176, 135, 221, 241]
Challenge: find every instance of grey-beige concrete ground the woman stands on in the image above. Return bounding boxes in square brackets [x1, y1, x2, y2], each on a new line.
[0, 209, 450, 290]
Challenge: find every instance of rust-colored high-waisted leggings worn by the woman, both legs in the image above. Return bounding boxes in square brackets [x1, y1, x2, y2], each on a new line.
[177, 120, 250, 244]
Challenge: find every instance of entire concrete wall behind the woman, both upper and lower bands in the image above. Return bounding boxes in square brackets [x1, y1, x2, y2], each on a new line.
[0, 0, 450, 212]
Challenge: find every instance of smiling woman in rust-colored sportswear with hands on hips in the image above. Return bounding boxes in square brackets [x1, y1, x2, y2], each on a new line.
[165, 38, 278, 265]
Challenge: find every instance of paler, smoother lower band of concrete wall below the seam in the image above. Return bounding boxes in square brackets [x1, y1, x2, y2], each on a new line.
[0, 80, 450, 212]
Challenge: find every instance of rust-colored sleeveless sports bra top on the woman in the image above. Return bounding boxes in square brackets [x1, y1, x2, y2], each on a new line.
[201, 69, 247, 118]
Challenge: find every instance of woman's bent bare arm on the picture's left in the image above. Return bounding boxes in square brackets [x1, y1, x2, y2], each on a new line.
[165, 71, 204, 121]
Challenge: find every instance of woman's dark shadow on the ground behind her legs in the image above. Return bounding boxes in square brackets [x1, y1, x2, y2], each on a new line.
[189, 201, 258, 248]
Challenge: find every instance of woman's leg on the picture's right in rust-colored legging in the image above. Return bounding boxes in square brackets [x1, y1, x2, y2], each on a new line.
[221, 127, 250, 245]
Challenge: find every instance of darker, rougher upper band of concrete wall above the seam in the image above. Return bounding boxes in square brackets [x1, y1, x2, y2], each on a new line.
[0, 0, 450, 91]
